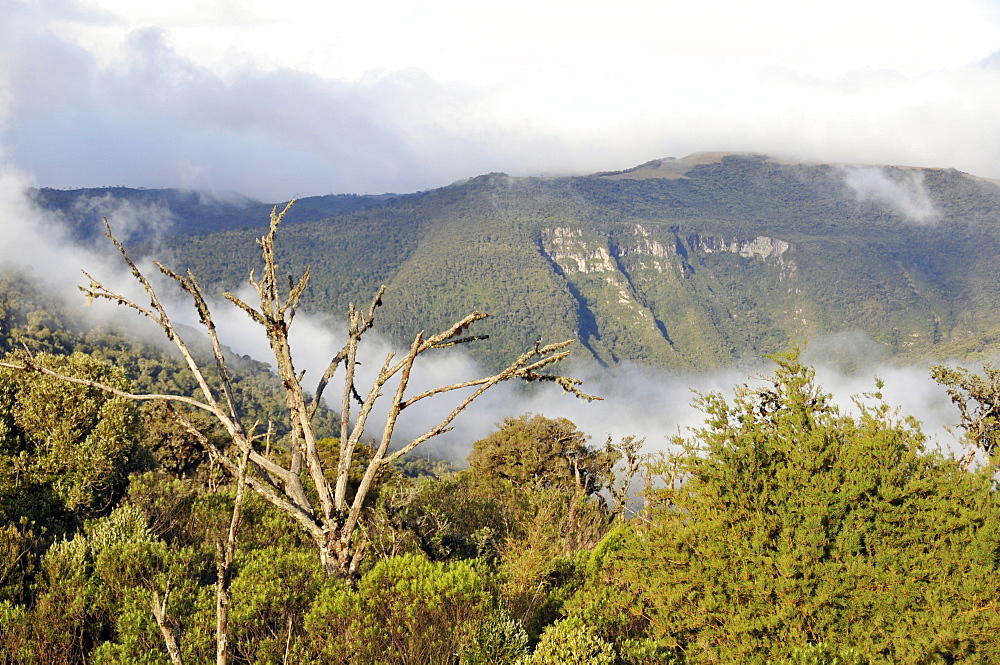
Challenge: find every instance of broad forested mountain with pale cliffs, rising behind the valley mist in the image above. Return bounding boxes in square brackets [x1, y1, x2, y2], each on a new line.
[29, 153, 1000, 369]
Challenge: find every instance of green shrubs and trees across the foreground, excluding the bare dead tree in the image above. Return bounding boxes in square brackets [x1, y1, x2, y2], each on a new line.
[0, 340, 1000, 663]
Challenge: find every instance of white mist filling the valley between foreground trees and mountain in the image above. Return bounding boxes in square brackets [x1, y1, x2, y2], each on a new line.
[0, 140, 957, 461]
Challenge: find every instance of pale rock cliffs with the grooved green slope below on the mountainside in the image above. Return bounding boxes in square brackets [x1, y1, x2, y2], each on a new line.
[540, 223, 810, 368]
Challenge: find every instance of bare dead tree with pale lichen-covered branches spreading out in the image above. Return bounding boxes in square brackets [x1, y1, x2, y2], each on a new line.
[0, 202, 594, 579]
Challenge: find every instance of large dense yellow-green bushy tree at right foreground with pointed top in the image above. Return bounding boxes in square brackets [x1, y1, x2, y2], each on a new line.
[571, 354, 1000, 663]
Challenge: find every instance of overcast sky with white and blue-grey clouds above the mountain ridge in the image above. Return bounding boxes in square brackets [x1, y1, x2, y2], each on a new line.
[0, 0, 1000, 201]
